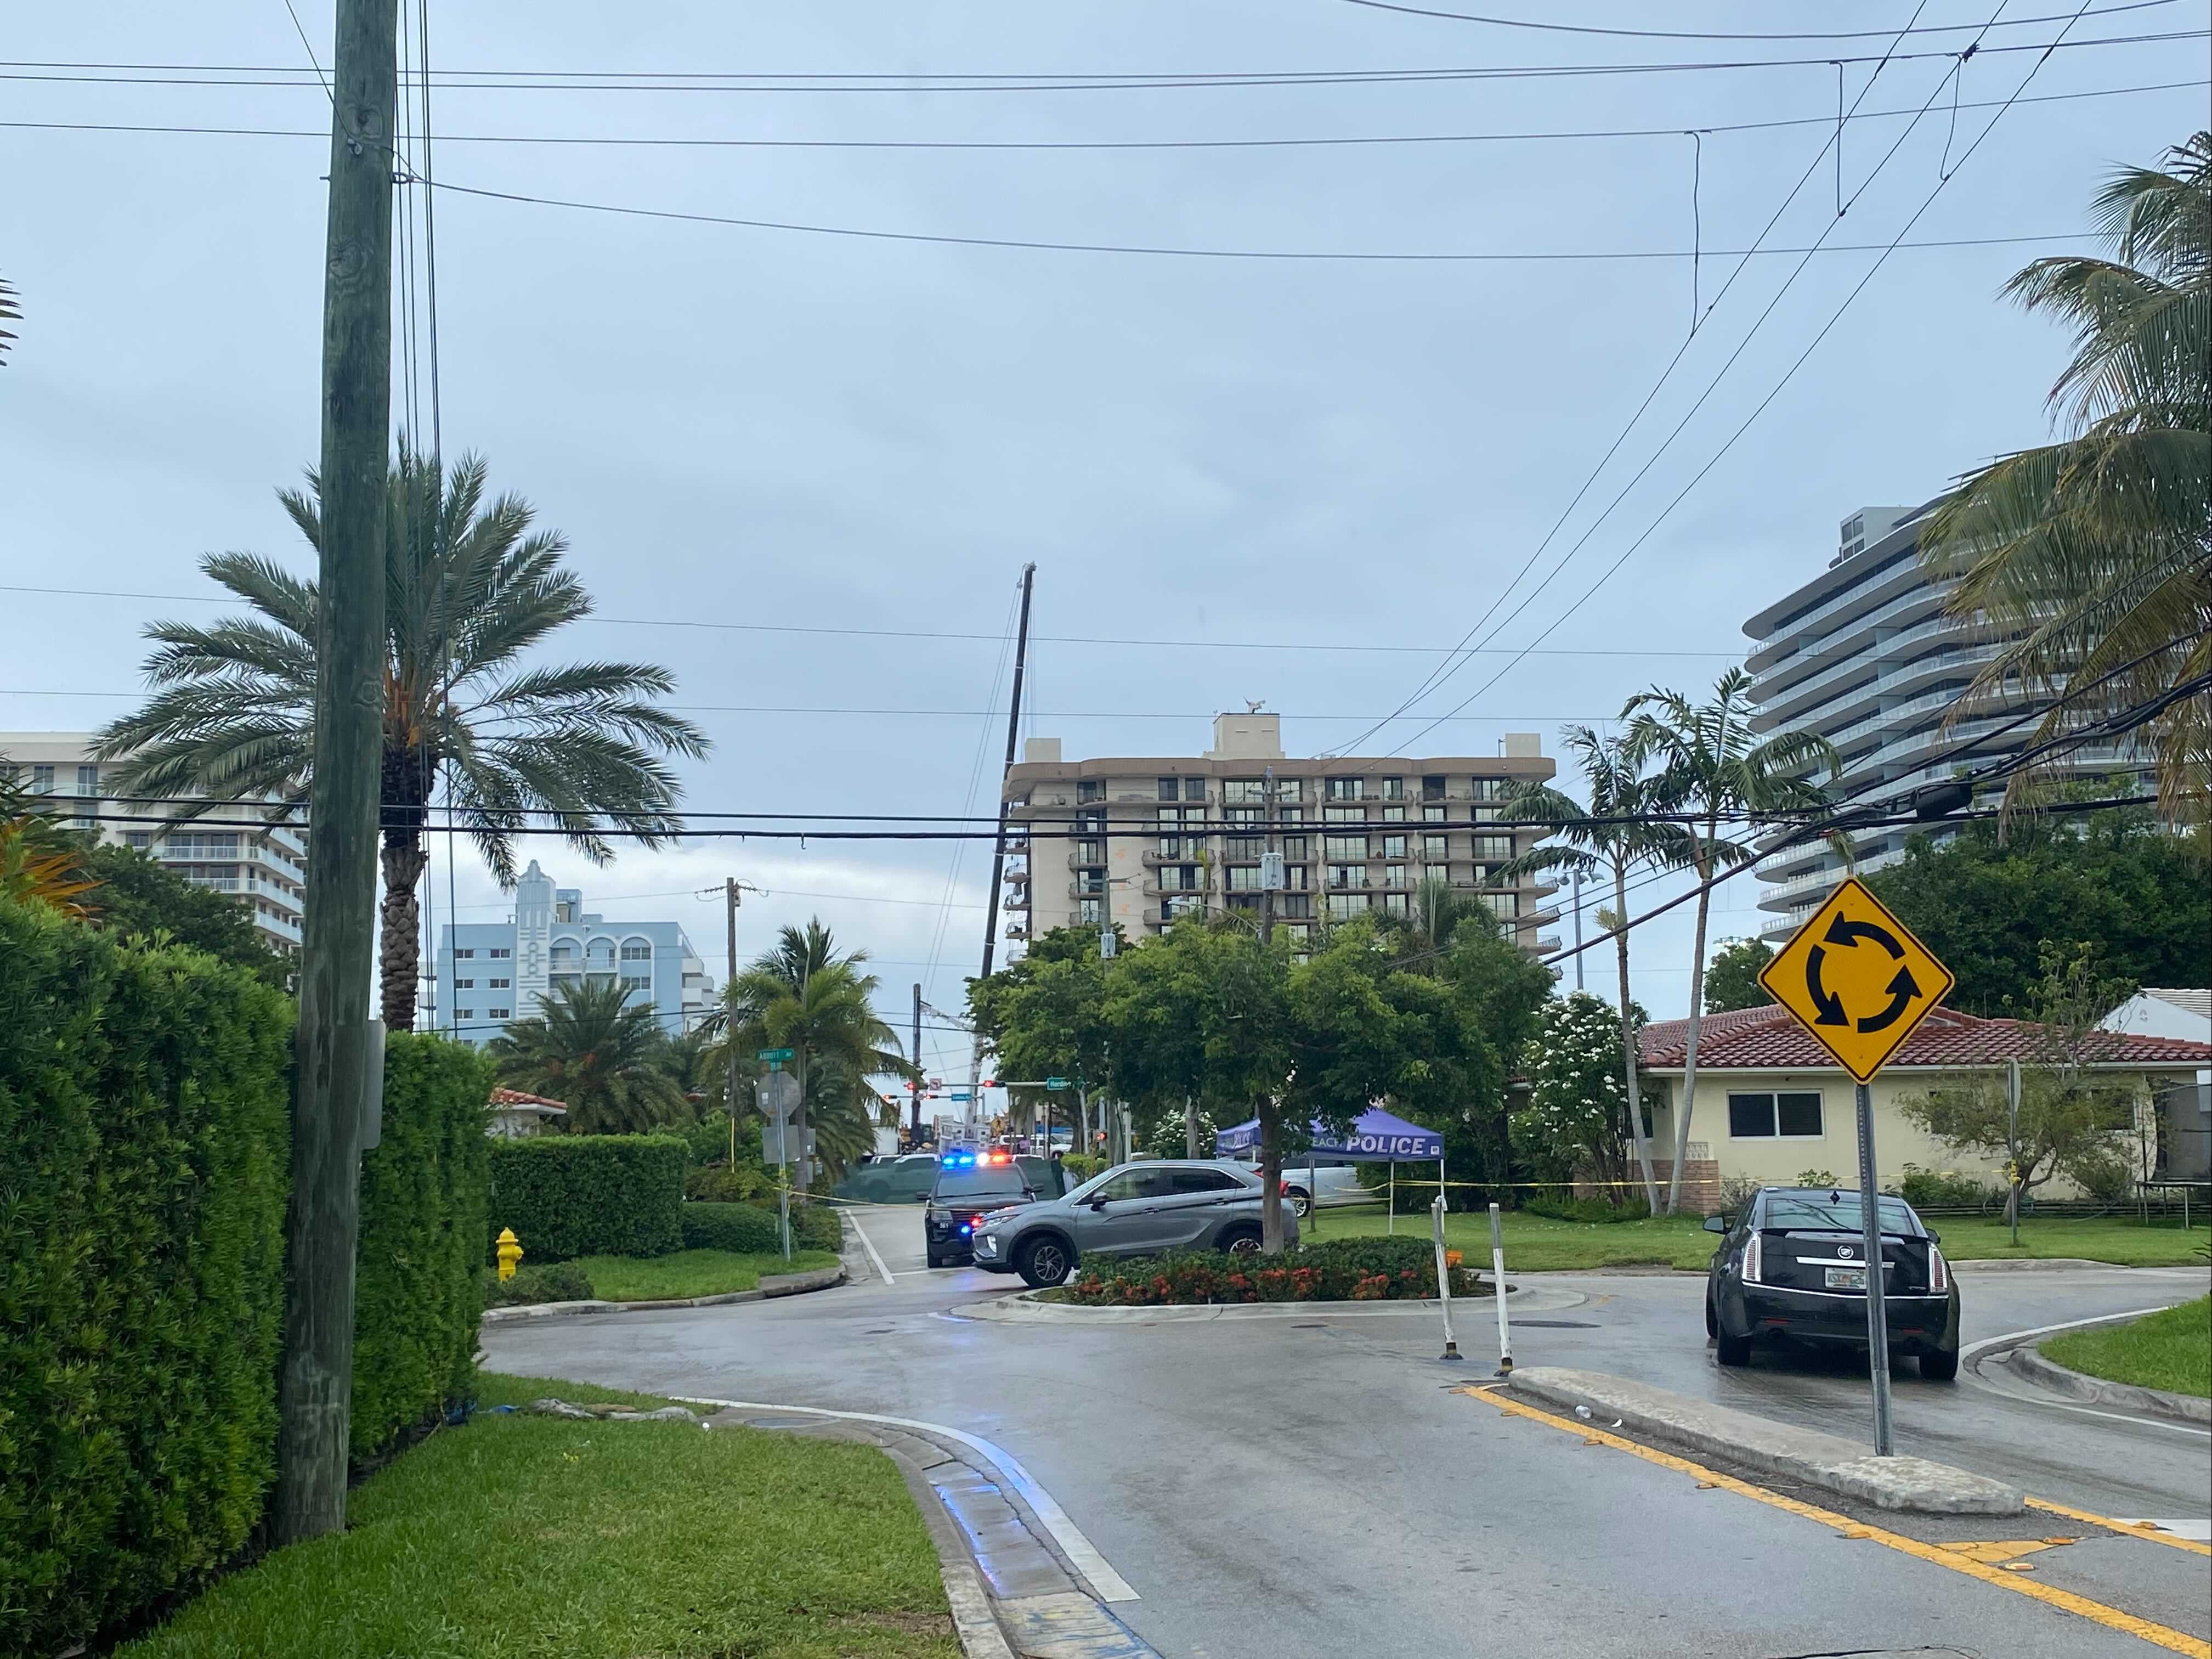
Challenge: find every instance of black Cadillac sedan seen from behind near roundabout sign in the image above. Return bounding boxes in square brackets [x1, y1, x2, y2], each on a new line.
[1705, 1186, 1958, 1383]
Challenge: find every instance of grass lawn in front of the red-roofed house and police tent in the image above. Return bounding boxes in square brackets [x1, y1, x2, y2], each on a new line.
[1300, 1205, 2212, 1272]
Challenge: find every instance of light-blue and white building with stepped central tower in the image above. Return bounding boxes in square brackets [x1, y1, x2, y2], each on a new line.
[425, 858, 715, 1044]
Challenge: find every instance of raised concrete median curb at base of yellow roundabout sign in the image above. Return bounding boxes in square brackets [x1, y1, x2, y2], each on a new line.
[1506, 1365, 2026, 1515]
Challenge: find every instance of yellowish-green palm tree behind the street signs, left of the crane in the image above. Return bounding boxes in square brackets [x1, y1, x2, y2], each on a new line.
[708, 920, 914, 1192]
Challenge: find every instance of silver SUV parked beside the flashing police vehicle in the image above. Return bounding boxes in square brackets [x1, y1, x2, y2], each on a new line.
[974, 1159, 1298, 1288]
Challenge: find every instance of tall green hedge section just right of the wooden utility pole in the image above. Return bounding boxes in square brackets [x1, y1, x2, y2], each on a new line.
[352, 1033, 491, 1462]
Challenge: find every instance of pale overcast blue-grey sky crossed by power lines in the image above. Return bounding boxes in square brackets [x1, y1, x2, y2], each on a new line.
[0, 0, 2208, 1070]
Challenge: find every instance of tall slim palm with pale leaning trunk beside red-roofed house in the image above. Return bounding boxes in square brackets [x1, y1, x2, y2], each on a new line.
[1621, 668, 1849, 1215]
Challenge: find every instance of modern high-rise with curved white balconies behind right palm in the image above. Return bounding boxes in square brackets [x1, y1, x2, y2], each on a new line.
[1743, 502, 2130, 940]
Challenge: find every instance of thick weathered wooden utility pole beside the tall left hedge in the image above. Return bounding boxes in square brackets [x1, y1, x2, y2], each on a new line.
[270, 0, 398, 1544]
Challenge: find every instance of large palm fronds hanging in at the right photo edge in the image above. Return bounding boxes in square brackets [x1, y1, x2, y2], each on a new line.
[1922, 131, 2212, 821]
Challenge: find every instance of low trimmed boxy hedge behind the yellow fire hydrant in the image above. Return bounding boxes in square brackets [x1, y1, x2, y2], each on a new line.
[484, 1135, 686, 1263]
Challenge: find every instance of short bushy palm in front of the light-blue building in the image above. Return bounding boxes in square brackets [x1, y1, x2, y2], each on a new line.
[491, 980, 692, 1135]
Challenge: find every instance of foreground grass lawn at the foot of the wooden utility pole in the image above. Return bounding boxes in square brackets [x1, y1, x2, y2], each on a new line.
[115, 1376, 960, 1659]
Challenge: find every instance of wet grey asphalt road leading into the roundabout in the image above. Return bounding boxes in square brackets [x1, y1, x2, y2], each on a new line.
[484, 1210, 2212, 1659]
